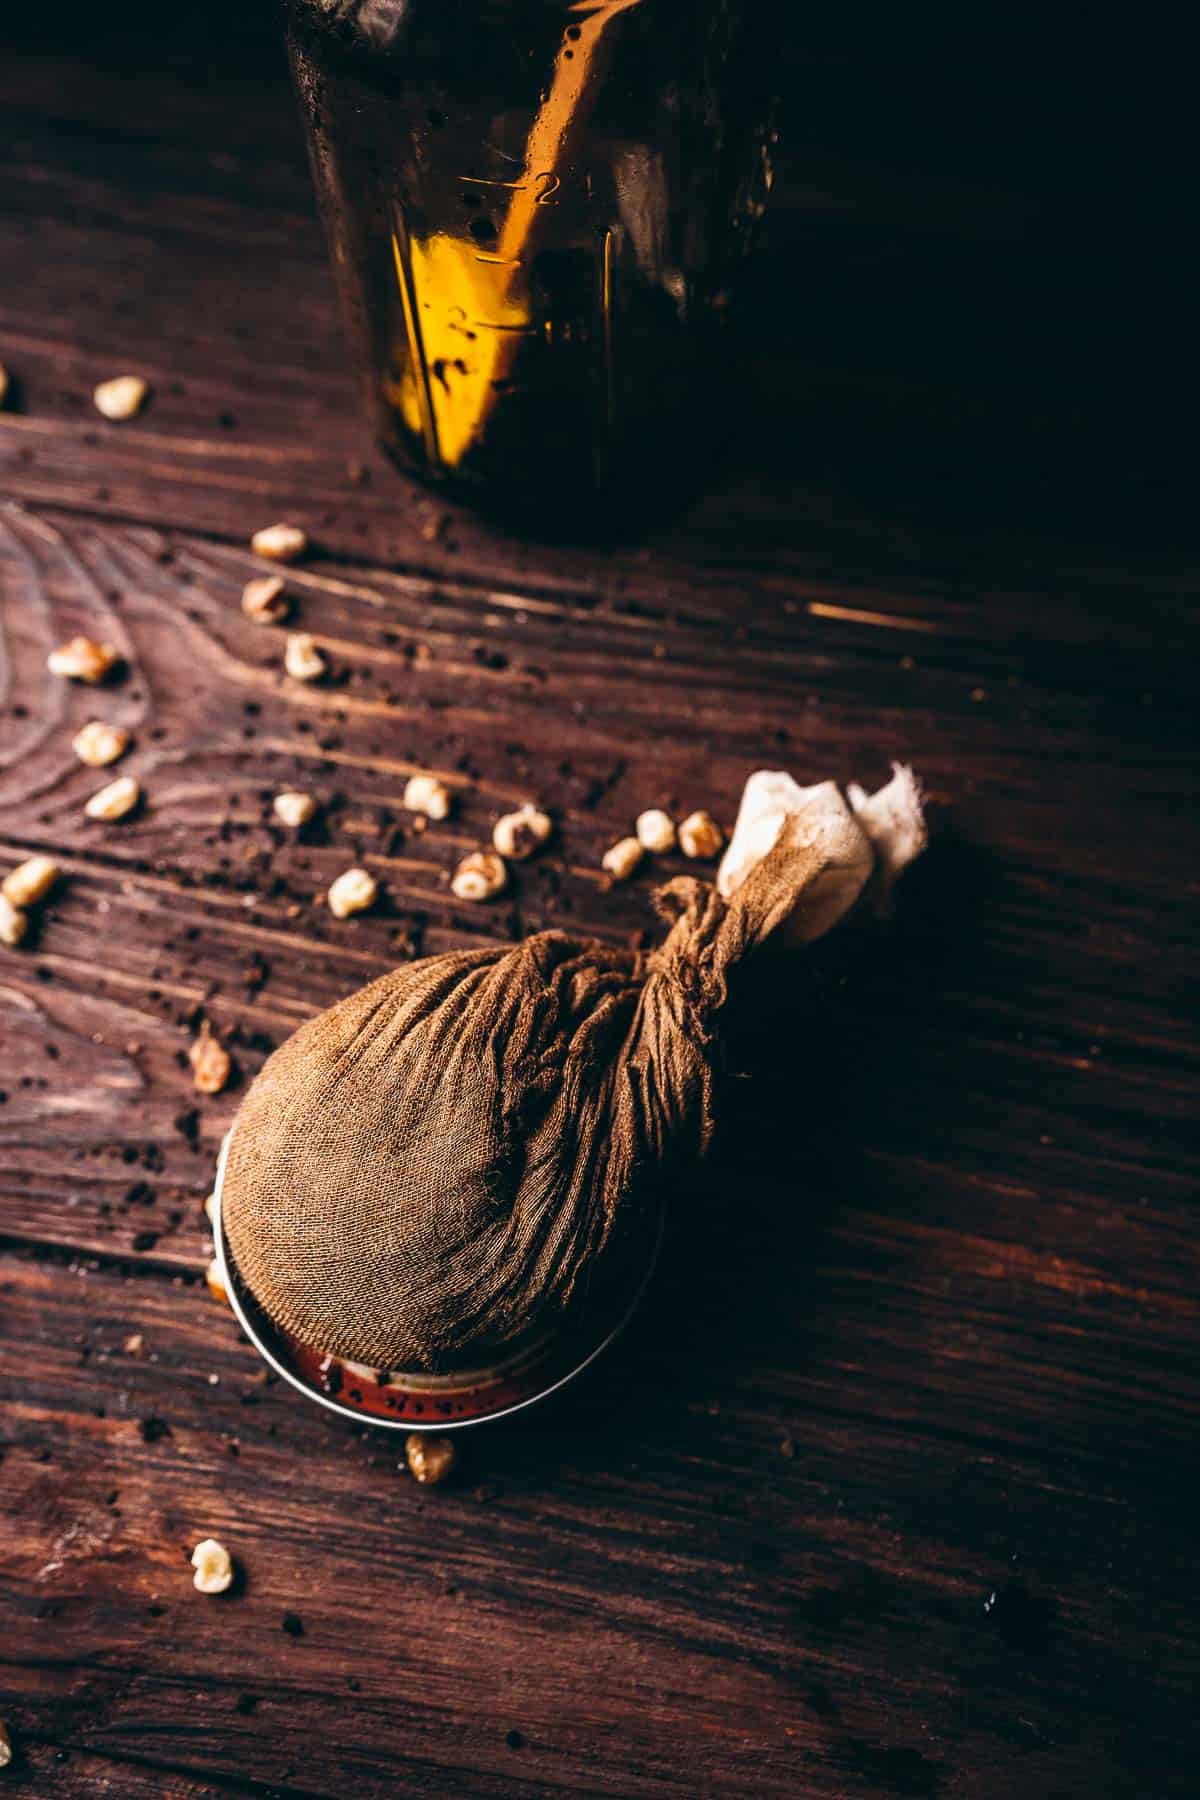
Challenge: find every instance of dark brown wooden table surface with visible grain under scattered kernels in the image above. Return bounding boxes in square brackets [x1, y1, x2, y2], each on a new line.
[0, 9, 1200, 1800]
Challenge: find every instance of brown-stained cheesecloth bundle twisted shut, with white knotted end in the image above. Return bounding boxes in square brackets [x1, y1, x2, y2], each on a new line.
[221, 767, 925, 1373]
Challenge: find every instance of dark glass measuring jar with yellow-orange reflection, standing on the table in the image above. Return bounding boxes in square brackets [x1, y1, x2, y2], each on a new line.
[288, 0, 770, 522]
